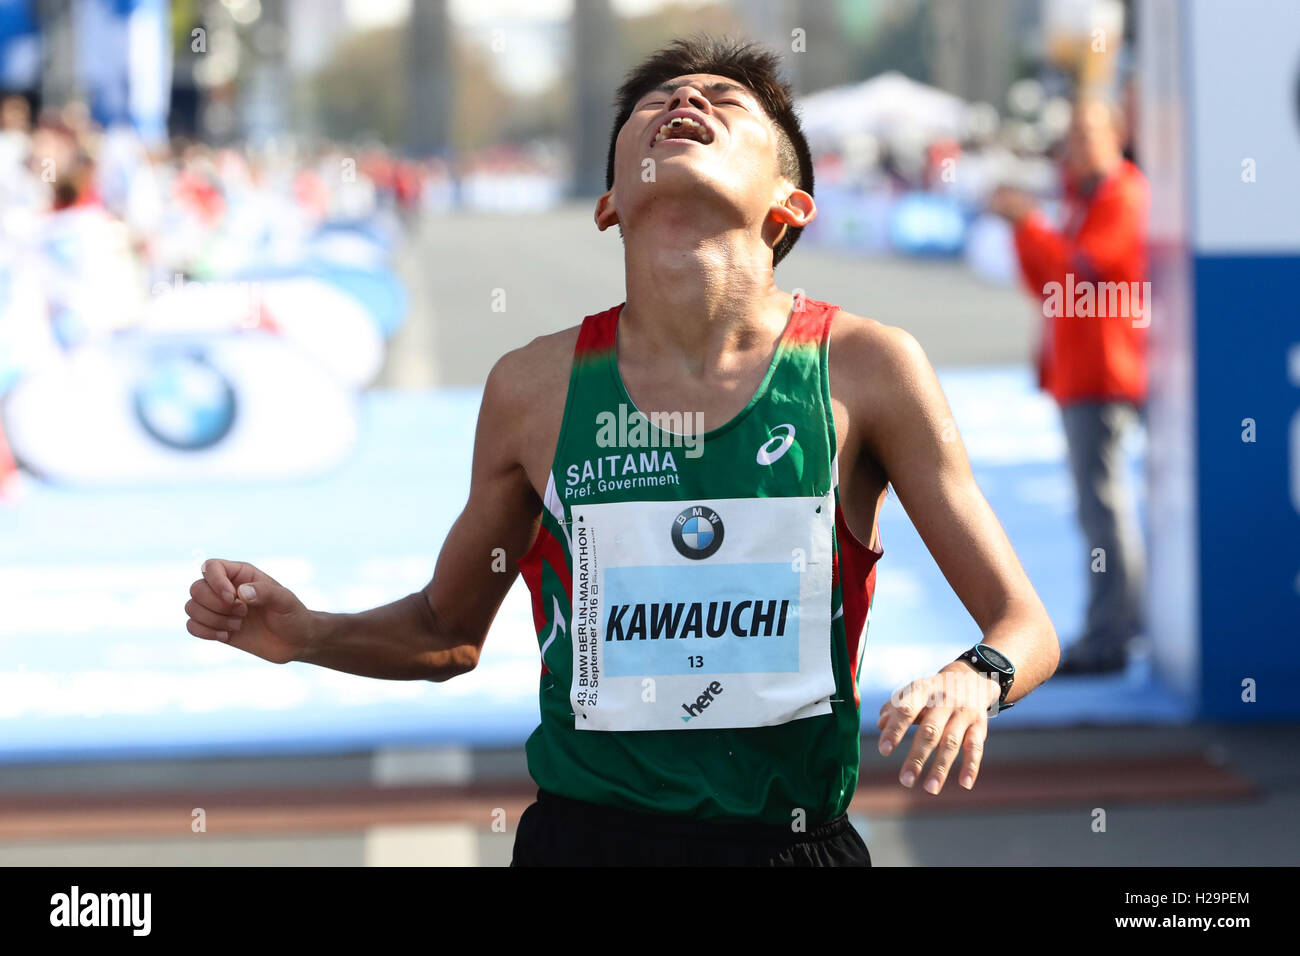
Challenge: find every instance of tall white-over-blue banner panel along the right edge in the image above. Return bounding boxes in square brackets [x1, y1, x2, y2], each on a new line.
[1139, 0, 1300, 722]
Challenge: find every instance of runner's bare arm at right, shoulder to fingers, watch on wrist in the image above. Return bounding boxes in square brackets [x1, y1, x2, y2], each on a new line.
[854, 325, 1060, 792]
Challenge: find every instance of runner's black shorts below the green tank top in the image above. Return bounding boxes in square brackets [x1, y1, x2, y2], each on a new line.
[510, 790, 871, 866]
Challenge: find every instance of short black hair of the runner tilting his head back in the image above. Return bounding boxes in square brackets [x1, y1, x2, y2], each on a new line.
[605, 35, 813, 267]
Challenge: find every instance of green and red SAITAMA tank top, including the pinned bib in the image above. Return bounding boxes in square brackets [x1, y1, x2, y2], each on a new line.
[519, 298, 881, 826]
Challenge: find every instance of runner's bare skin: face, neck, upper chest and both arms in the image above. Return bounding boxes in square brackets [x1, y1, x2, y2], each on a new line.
[186, 74, 1060, 793]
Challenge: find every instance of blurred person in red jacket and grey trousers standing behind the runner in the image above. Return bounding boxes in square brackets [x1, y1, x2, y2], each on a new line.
[989, 96, 1151, 675]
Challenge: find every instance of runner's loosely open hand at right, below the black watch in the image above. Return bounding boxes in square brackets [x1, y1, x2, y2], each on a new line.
[876, 661, 1001, 793]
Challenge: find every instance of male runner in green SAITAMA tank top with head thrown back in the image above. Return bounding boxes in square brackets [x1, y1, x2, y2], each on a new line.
[186, 39, 1058, 866]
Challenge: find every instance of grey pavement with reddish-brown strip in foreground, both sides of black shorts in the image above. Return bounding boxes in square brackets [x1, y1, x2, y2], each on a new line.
[0, 724, 1300, 868]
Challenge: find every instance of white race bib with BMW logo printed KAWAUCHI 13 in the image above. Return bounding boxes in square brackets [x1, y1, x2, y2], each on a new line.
[569, 493, 835, 731]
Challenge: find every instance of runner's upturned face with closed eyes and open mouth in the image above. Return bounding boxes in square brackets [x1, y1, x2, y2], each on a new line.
[603, 73, 793, 221]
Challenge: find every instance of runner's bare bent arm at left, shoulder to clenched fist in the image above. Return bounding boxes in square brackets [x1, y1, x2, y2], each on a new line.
[185, 347, 541, 680]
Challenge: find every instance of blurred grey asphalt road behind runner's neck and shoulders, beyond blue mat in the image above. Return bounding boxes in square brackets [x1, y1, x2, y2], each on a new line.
[380, 203, 1035, 388]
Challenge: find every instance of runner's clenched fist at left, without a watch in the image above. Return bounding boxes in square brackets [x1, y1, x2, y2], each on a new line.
[185, 558, 312, 663]
